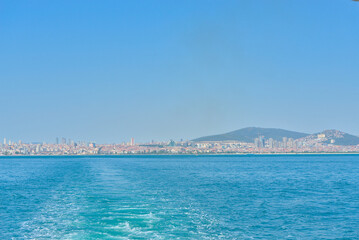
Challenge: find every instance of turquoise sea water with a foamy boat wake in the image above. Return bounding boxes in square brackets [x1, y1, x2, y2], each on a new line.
[0, 155, 359, 239]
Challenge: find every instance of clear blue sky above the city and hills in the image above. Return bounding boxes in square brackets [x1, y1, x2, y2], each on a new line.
[0, 0, 359, 143]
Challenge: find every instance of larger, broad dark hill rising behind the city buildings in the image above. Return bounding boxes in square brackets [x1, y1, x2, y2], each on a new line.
[193, 127, 309, 142]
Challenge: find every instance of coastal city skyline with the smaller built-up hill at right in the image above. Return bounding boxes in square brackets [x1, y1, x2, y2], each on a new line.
[0, 130, 359, 156]
